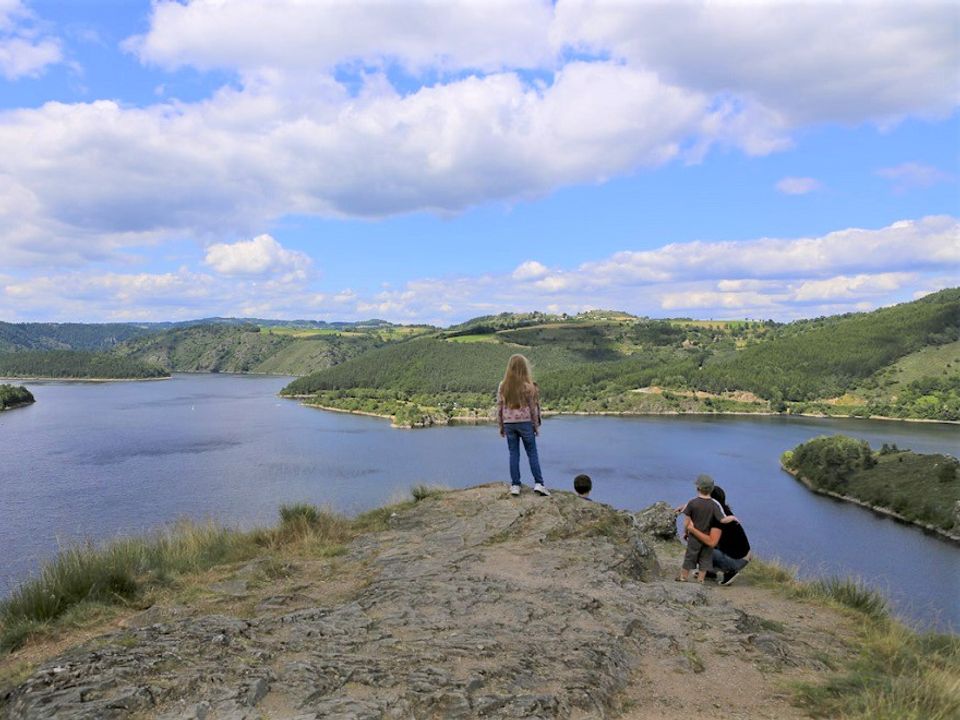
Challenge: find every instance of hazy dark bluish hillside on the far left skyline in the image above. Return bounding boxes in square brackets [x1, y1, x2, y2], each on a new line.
[0, 322, 152, 353]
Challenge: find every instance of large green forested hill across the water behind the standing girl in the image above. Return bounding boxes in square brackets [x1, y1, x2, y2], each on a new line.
[284, 288, 960, 420]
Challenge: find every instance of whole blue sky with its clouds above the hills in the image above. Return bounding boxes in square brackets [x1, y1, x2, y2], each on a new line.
[0, 0, 960, 325]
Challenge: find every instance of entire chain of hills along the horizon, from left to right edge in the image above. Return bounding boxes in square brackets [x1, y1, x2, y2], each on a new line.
[0, 288, 960, 424]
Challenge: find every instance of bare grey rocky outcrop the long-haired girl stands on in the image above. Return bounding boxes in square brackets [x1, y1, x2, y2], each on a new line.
[0, 485, 856, 720]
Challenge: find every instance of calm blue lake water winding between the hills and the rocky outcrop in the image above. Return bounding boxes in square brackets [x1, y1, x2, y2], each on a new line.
[0, 375, 960, 630]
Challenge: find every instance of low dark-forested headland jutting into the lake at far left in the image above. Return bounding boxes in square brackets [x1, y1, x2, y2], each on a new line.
[0, 350, 169, 380]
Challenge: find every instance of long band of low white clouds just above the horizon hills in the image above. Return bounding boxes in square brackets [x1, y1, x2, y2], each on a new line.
[0, 216, 960, 324]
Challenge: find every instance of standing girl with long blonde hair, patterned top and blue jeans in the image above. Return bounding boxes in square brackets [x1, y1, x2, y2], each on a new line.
[497, 355, 550, 495]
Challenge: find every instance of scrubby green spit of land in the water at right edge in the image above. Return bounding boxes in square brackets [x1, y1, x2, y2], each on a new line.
[780, 435, 960, 543]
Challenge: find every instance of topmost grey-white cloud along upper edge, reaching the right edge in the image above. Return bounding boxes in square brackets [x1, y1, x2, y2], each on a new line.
[128, 0, 960, 131]
